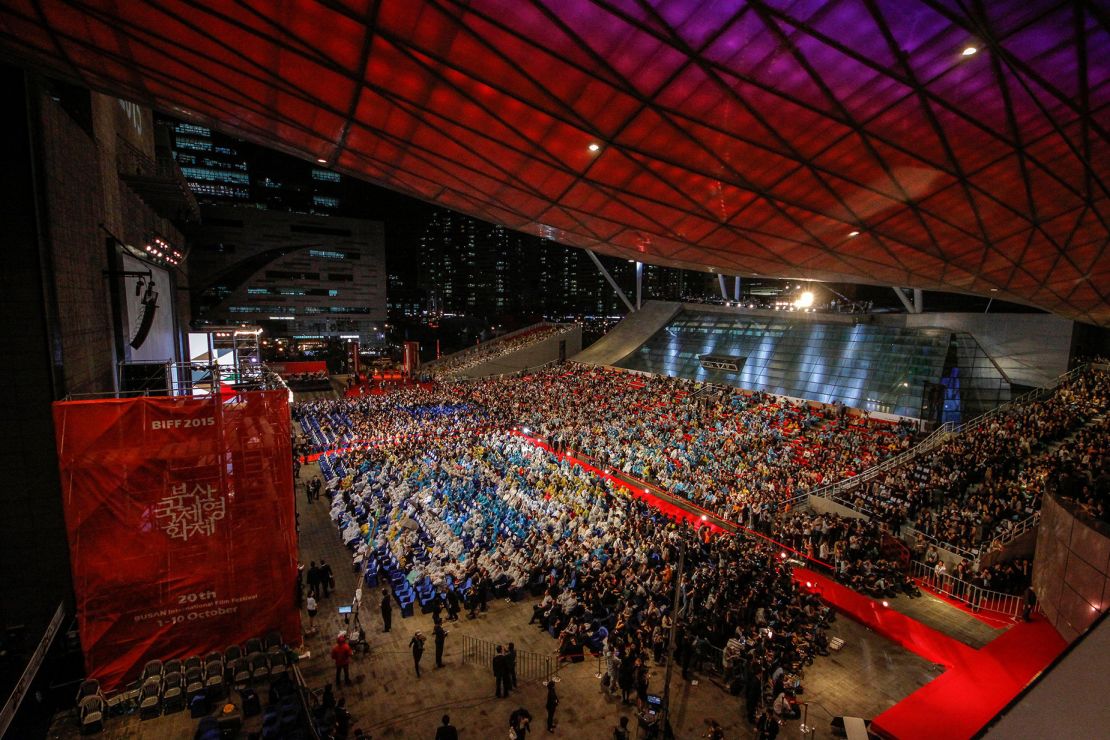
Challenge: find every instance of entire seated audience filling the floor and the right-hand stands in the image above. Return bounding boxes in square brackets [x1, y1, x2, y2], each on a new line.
[294, 357, 1110, 737]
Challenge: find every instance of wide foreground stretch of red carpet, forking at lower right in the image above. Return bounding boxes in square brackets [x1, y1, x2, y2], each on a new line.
[794, 568, 1066, 740]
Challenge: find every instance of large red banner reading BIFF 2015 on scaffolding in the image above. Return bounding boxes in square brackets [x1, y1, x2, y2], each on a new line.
[53, 391, 301, 688]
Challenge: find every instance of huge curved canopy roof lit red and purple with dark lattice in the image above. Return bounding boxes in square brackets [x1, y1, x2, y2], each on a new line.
[0, 0, 1110, 325]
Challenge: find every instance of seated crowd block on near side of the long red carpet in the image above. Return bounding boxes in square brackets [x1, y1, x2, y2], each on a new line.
[317, 432, 830, 723]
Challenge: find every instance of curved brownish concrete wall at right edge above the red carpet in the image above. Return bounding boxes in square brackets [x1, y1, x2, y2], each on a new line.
[1033, 495, 1110, 642]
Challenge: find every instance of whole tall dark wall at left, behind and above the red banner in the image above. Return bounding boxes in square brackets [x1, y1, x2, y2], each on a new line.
[0, 64, 188, 718]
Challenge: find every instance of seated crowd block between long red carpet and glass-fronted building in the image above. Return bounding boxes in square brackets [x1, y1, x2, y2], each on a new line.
[454, 365, 915, 523]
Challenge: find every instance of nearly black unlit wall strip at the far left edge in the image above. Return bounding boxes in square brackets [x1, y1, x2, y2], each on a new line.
[0, 65, 72, 710]
